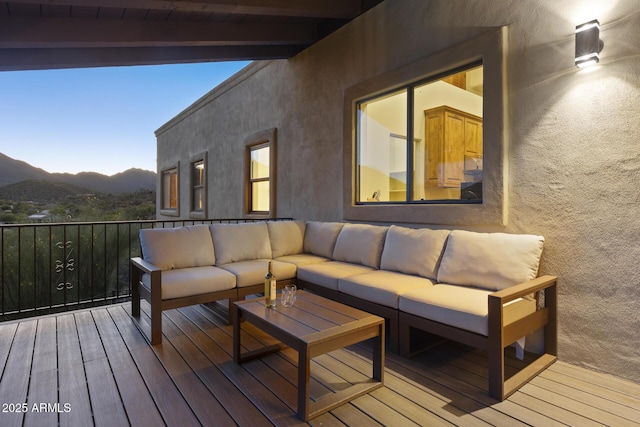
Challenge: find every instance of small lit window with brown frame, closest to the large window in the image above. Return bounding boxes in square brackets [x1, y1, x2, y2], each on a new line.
[245, 129, 276, 217]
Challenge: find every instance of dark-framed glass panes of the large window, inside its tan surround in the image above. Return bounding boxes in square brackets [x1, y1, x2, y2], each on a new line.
[356, 64, 483, 203]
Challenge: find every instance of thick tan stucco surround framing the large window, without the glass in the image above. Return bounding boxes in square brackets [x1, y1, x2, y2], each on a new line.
[343, 27, 507, 225]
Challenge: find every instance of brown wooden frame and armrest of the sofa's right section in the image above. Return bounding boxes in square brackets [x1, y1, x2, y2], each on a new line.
[298, 276, 558, 401]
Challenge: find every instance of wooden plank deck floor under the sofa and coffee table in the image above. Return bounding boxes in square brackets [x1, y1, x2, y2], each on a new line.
[0, 304, 640, 427]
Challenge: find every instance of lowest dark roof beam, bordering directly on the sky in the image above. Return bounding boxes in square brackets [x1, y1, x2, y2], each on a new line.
[0, 46, 298, 71]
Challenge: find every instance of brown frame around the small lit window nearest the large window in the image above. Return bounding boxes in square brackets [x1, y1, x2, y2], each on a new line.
[244, 128, 277, 218]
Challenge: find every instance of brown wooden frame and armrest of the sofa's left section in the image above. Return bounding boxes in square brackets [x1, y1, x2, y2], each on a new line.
[130, 257, 295, 345]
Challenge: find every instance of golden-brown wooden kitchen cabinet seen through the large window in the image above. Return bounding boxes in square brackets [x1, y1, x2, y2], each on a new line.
[424, 106, 482, 188]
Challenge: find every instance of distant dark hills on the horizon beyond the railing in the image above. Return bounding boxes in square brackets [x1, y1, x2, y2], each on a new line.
[0, 153, 156, 194]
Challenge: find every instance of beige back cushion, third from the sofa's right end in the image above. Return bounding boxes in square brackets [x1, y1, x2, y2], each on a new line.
[333, 224, 389, 268]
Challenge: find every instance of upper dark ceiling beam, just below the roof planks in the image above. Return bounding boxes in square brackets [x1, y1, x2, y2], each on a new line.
[0, 17, 317, 48]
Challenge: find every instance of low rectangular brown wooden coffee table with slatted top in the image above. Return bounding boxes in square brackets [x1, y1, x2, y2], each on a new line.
[233, 291, 384, 421]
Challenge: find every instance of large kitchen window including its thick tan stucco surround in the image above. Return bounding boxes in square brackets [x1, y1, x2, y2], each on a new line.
[343, 27, 508, 225]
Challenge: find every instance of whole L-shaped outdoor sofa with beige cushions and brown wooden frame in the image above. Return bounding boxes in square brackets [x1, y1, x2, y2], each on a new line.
[131, 221, 557, 400]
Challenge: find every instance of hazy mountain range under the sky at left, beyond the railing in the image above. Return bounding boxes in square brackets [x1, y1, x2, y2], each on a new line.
[0, 153, 156, 200]
